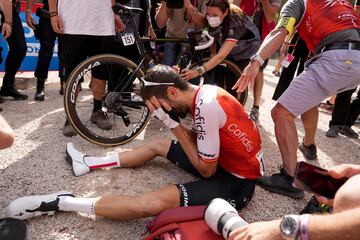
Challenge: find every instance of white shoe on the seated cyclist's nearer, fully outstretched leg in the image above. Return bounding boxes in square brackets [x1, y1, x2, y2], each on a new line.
[2, 192, 75, 220]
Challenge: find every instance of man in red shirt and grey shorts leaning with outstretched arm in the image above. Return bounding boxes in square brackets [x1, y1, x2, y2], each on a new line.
[234, 0, 360, 198]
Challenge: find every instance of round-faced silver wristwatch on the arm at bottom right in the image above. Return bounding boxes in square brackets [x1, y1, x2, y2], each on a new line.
[280, 215, 300, 240]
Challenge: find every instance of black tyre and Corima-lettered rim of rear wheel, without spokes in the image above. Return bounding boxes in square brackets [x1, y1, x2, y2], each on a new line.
[64, 54, 151, 147]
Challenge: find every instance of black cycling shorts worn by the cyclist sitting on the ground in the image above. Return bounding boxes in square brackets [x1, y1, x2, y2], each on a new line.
[166, 141, 255, 209]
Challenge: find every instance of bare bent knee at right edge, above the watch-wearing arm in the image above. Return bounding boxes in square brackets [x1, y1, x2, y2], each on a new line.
[334, 174, 360, 212]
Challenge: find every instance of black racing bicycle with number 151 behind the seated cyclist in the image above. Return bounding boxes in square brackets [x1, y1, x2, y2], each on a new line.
[64, 4, 248, 146]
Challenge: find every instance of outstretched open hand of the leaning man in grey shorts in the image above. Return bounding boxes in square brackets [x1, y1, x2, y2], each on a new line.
[232, 61, 260, 93]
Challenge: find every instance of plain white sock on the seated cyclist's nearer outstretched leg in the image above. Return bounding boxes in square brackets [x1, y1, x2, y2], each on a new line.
[58, 196, 98, 215]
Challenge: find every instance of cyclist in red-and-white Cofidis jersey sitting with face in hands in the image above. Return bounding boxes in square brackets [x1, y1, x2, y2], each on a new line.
[4, 65, 263, 220]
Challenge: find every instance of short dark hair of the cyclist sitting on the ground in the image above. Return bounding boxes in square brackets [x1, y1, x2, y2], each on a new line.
[140, 64, 189, 100]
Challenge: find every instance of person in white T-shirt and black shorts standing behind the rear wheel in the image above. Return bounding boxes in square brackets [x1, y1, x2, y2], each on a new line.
[49, 0, 124, 137]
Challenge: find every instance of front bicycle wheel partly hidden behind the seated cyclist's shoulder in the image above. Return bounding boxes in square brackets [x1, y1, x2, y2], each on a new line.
[190, 58, 248, 106]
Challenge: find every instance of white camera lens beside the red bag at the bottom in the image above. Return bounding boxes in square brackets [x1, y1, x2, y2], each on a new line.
[204, 198, 248, 239]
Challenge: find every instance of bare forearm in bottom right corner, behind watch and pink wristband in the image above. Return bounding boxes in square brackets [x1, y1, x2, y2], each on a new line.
[308, 207, 360, 240]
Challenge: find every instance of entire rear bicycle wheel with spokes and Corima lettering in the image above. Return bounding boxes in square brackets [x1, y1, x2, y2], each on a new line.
[64, 54, 150, 146]
